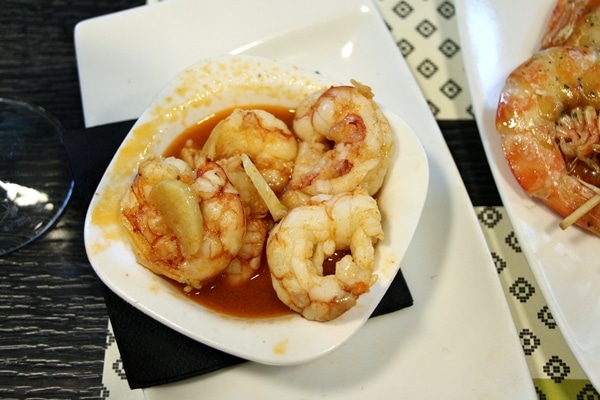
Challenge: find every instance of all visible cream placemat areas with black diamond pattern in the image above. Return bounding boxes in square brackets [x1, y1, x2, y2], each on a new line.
[102, 0, 600, 400]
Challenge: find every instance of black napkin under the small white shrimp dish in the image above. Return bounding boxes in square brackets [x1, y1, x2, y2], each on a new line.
[65, 121, 413, 389]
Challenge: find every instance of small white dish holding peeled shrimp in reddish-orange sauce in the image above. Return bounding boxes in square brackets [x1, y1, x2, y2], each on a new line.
[84, 55, 429, 365]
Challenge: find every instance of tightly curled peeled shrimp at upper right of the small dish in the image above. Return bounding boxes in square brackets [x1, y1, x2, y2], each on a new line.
[289, 81, 394, 208]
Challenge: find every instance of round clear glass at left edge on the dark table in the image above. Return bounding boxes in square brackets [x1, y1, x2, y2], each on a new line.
[0, 98, 73, 256]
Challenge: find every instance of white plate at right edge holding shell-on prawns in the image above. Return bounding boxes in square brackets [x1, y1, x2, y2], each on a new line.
[457, 0, 600, 387]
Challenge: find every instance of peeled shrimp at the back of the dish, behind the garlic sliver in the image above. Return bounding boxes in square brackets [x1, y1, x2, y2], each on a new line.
[200, 109, 298, 214]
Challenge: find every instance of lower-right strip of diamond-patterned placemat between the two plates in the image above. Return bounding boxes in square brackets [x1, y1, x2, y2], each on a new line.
[475, 206, 600, 400]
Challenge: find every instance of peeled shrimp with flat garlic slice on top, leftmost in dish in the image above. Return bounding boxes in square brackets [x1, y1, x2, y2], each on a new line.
[121, 157, 246, 288]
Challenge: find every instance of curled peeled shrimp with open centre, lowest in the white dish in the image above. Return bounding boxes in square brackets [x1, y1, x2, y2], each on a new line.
[267, 189, 383, 321]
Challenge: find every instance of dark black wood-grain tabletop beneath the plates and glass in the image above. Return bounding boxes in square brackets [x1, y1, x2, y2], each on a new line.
[0, 0, 500, 399]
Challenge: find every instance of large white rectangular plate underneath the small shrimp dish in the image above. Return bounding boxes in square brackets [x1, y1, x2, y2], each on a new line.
[75, 0, 537, 399]
